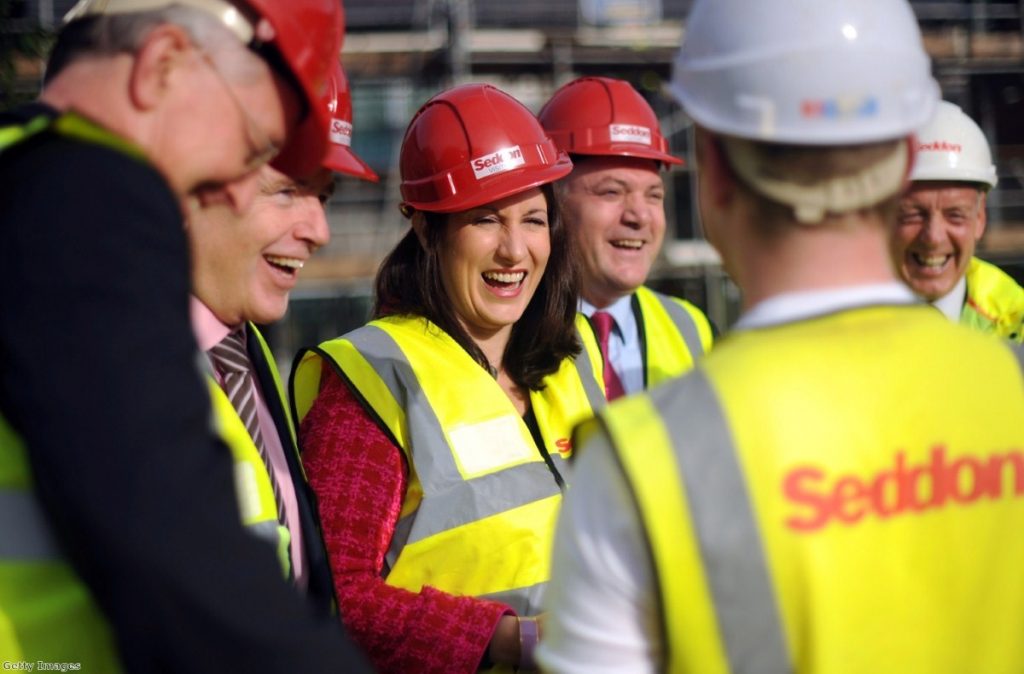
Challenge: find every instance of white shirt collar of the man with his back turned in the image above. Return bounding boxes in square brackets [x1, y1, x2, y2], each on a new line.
[733, 281, 921, 330]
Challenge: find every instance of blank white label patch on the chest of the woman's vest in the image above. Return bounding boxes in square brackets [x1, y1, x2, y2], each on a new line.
[449, 415, 537, 477]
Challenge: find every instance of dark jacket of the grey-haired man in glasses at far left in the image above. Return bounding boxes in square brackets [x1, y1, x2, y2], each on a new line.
[0, 134, 369, 674]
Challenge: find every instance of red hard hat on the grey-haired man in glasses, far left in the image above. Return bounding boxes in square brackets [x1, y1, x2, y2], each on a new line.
[245, 0, 345, 176]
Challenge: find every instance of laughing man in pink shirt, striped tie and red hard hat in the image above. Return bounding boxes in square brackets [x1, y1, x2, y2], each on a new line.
[186, 64, 378, 612]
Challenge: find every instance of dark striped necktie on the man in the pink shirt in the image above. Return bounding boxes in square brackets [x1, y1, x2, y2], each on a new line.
[208, 328, 288, 529]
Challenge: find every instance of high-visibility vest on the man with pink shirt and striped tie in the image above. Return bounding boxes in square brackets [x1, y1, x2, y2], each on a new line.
[207, 323, 295, 579]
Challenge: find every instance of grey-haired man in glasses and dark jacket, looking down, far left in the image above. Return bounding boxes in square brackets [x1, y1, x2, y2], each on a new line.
[0, 0, 364, 672]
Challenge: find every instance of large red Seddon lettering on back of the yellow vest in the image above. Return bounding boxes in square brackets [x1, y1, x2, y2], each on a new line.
[782, 445, 1024, 532]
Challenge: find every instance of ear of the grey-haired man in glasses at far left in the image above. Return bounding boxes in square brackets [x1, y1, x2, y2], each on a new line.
[128, 24, 194, 111]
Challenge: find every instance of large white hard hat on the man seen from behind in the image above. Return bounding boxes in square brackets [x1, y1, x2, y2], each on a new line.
[671, 0, 939, 145]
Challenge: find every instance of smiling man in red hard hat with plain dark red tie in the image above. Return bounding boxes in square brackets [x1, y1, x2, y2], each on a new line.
[539, 77, 713, 399]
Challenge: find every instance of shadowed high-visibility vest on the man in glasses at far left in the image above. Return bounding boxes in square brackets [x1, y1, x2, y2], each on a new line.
[0, 114, 144, 673]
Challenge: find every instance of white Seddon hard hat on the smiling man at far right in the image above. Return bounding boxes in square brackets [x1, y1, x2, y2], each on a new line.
[910, 100, 998, 187]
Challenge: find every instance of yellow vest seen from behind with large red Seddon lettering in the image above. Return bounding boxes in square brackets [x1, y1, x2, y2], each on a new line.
[601, 306, 1024, 674]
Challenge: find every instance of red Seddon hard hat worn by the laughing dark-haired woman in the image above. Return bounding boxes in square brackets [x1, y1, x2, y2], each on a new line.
[399, 84, 572, 213]
